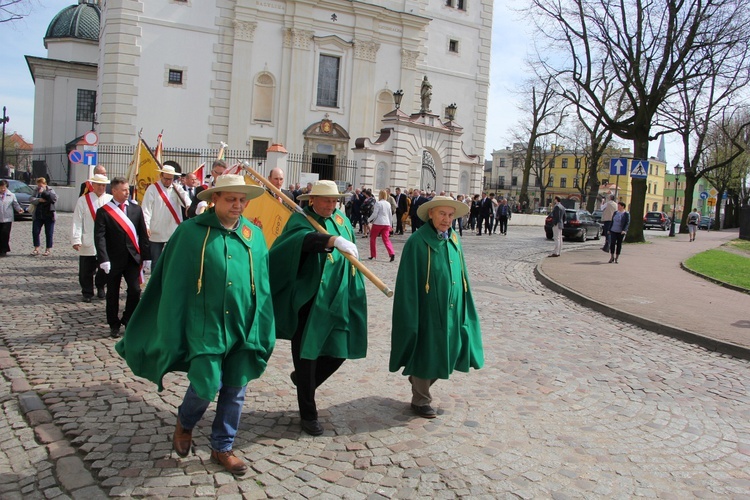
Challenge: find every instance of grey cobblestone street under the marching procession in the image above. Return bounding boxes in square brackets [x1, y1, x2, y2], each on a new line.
[0, 214, 750, 499]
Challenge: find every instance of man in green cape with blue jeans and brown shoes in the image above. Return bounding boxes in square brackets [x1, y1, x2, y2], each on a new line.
[115, 175, 275, 475]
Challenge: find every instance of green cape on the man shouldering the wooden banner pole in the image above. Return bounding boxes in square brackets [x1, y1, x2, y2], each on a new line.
[270, 207, 367, 359]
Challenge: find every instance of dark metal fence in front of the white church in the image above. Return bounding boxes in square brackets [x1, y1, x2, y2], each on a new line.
[32, 145, 357, 186]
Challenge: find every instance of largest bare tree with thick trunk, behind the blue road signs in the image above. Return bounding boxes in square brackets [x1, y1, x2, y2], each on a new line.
[528, 0, 748, 242]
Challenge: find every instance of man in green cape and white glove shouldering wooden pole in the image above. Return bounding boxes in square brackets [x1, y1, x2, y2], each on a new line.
[270, 181, 367, 436]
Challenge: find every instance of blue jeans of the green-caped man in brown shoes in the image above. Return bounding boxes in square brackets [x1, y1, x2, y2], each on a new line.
[177, 384, 247, 452]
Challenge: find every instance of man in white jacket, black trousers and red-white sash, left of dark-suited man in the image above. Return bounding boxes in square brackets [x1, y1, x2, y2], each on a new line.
[70, 174, 112, 302]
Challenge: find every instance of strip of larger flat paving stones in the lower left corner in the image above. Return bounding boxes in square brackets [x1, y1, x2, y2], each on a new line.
[0, 349, 107, 500]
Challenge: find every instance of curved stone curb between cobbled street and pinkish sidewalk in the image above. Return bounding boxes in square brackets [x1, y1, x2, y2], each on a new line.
[534, 261, 750, 360]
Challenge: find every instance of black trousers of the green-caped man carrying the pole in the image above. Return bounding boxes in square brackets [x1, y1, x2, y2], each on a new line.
[292, 301, 344, 420]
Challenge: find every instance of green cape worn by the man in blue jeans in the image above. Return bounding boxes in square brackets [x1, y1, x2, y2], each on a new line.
[115, 210, 275, 401]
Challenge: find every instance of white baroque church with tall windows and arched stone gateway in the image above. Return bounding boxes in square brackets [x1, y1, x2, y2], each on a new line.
[30, 0, 492, 191]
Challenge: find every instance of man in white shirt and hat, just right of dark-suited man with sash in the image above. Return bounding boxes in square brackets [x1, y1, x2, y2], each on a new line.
[141, 165, 190, 266]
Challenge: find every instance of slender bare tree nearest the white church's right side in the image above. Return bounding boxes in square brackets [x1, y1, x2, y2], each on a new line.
[519, 77, 565, 207]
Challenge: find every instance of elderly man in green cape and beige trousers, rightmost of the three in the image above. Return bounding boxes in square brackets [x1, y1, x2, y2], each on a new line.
[390, 196, 484, 418]
